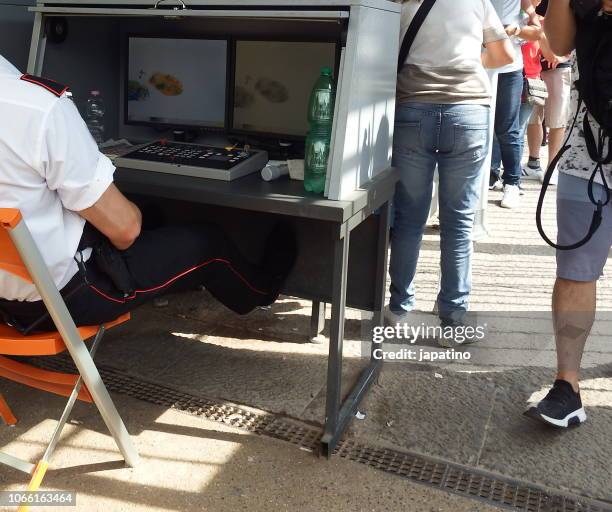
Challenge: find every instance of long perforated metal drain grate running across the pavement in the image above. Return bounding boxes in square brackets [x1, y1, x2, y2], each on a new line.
[28, 356, 612, 512]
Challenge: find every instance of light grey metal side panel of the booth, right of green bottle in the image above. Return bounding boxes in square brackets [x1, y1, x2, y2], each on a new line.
[328, 4, 400, 199]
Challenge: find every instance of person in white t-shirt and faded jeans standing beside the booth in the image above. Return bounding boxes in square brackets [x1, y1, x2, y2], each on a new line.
[386, 0, 513, 336]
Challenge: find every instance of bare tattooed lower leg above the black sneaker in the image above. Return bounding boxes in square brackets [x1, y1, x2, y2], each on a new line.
[552, 278, 597, 392]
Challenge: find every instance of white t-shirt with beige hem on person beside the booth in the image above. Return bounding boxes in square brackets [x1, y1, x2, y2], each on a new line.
[397, 0, 508, 105]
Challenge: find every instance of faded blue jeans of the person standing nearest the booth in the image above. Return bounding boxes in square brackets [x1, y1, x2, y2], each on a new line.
[389, 103, 489, 319]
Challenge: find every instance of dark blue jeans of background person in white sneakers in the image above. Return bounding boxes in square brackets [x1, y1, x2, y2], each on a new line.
[491, 70, 523, 185]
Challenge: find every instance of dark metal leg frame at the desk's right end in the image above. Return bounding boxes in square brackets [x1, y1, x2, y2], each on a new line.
[321, 203, 389, 458]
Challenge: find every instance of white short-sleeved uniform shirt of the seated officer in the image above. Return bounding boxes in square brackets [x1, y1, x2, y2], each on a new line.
[0, 55, 115, 301]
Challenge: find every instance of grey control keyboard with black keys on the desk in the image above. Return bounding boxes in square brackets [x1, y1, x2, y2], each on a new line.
[114, 140, 268, 181]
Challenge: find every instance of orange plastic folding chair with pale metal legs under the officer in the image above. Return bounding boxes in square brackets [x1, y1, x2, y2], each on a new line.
[0, 208, 138, 511]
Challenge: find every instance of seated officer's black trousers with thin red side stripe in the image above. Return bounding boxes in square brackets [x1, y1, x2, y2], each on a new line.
[0, 225, 280, 331]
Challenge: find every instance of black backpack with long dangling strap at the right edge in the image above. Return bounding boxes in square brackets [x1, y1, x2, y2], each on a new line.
[536, 4, 612, 250]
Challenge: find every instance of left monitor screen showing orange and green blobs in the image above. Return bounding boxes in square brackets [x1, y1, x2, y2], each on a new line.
[126, 37, 228, 128]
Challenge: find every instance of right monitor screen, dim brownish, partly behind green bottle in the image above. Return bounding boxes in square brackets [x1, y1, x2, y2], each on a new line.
[232, 41, 336, 137]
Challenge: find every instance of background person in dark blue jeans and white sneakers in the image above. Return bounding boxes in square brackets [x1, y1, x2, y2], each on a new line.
[489, 0, 542, 208]
